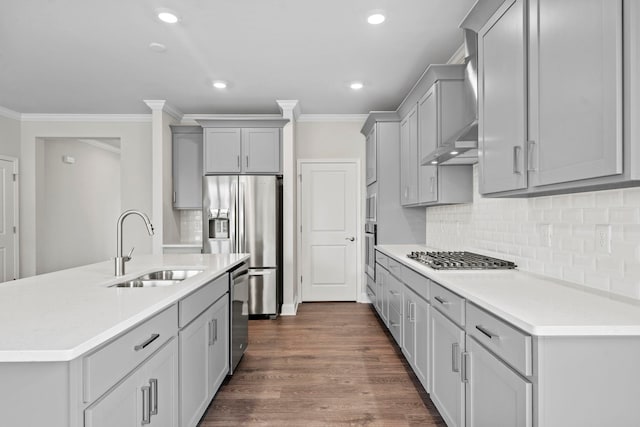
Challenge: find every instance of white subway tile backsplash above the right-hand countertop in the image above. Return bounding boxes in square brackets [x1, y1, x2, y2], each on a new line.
[426, 167, 640, 299]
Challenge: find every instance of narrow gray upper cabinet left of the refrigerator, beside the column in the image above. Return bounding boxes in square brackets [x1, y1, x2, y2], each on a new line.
[171, 126, 202, 209]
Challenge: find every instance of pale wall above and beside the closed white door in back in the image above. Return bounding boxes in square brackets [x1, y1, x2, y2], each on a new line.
[295, 116, 366, 299]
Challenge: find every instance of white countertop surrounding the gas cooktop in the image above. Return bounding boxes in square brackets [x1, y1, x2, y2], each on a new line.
[376, 245, 640, 336]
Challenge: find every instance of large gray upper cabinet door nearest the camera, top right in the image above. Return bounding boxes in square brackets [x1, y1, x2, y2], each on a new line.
[528, 0, 622, 186]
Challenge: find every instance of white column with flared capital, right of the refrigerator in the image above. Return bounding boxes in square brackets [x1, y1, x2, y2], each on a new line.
[276, 100, 300, 316]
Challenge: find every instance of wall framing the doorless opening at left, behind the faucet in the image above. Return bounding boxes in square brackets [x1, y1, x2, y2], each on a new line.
[20, 117, 153, 277]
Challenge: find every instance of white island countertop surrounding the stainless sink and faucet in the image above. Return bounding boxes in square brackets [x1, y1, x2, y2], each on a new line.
[0, 254, 249, 362]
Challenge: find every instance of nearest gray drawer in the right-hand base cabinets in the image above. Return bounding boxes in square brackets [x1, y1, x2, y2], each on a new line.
[466, 304, 532, 375]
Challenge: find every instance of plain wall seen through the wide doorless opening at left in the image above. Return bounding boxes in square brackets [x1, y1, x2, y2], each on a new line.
[36, 139, 120, 274]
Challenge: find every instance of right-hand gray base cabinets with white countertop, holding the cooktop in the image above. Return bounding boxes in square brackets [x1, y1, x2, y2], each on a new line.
[376, 245, 640, 427]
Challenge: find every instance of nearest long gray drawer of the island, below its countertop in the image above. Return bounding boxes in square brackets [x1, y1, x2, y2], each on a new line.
[82, 304, 178, 402]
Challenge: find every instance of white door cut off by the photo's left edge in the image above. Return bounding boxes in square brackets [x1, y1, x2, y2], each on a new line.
[0, 159, 18, 282]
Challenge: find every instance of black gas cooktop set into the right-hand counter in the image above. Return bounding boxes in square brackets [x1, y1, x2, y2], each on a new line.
[407, 251, 517, 270]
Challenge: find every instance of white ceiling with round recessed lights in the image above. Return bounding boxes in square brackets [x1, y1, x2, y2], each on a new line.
[0, 0, 473, 114]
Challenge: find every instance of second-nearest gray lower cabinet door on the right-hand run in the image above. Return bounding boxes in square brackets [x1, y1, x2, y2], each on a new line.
[429, 310, 465, 427]
